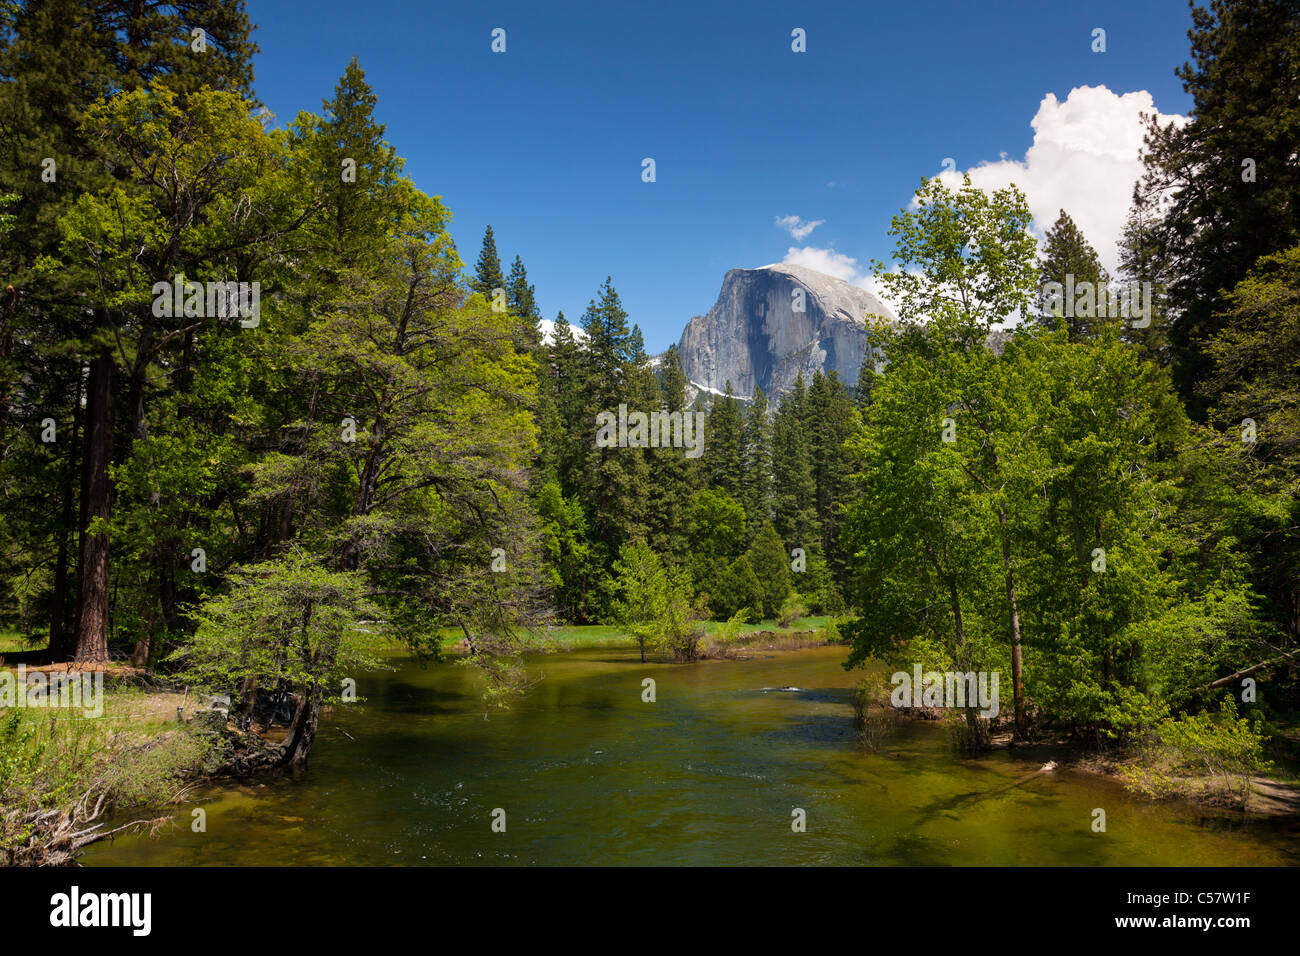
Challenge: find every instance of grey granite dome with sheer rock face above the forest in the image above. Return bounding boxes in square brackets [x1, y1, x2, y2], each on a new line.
[679, 263, 893, 401]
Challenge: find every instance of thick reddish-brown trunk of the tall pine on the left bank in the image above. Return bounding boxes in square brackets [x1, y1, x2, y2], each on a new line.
[75, 349, 113, 665]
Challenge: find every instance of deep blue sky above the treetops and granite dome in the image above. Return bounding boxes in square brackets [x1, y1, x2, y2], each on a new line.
[247, 0, 1191, 352]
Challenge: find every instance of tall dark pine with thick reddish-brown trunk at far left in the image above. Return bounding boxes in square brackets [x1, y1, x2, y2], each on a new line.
[0, 0, 256, 662]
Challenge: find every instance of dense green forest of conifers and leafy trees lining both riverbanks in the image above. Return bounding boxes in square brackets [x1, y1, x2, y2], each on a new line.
[0, 0, 1300, 868]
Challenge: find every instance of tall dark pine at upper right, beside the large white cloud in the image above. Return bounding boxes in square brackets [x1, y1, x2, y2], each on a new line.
[1143, 0, 1300, 419]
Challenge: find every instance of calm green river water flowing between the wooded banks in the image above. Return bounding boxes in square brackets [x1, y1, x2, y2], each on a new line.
[83, 648, 1300, 866]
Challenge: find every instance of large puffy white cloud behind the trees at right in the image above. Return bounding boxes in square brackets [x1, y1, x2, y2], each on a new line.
[939, 86, 1187, 274]
